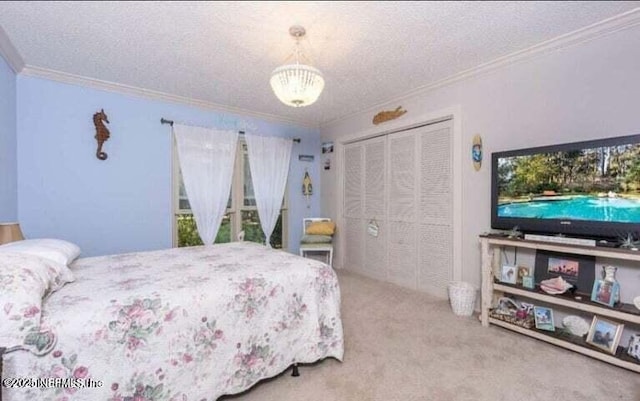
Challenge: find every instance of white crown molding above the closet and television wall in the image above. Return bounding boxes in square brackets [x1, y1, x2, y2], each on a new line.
[321, 7, 640, 127]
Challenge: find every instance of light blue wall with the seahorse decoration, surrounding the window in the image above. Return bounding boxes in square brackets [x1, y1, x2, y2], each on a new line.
[17, 76, 320, 256]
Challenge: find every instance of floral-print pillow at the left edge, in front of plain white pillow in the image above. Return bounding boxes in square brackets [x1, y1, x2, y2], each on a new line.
[0, 252, 58, 347]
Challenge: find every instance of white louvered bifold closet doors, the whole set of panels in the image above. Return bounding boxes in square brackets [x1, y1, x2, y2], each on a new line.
[342, 121, 453, 297]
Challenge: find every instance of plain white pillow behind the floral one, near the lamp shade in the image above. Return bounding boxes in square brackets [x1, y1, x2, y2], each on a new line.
[0, 238, 80, 266]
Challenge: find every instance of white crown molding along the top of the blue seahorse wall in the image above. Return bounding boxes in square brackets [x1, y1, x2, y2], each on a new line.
[20, 64, 319, 129]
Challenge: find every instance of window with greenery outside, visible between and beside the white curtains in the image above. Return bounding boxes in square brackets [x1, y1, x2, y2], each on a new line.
[173, 138, 287, 248]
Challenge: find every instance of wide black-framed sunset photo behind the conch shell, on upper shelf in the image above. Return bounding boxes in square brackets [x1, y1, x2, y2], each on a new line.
[535, 249, 596, 295]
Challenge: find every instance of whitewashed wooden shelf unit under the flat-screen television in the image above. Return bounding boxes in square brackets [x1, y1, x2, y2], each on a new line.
[480, 235, 640, 373]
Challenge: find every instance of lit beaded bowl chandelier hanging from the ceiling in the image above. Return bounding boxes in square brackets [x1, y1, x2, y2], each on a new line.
[270, 25, 324, 107]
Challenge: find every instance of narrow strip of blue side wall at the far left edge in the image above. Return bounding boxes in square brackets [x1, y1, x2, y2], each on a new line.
[0, 56, 18, 222]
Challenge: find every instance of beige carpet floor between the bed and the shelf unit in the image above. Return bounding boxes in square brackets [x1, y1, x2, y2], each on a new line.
[221, 270, 640, 401]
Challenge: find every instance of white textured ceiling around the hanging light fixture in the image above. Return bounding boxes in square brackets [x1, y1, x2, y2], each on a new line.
[0, 1, 640, 126]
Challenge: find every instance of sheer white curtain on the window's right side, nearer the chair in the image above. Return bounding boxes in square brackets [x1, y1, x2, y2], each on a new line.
[245, 134, 293, 246]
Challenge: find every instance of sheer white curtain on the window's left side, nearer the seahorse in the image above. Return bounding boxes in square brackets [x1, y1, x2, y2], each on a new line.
[173, 124, 238, 245]
